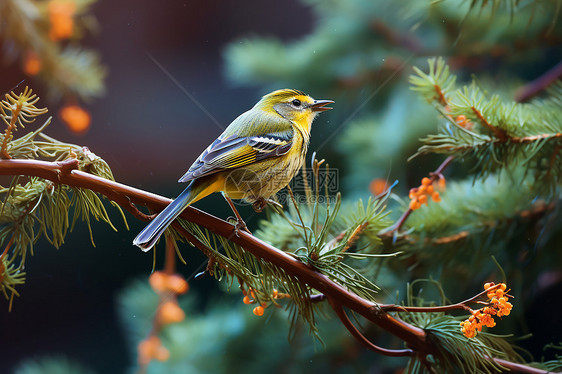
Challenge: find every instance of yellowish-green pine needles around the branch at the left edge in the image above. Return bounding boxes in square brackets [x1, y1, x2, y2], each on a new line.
[0, 87, 126, 308]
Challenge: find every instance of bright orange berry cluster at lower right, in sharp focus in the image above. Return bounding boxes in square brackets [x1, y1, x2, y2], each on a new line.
[461, 282, 513, 338]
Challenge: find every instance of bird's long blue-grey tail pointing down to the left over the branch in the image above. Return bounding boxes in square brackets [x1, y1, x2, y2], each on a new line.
[133, 181, 195, 252]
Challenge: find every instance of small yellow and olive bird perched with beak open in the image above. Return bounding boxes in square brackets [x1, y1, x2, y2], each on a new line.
[133, 89, 334, 252]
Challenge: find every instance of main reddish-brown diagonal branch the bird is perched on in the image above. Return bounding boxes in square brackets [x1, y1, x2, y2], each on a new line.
[0, 159, 546, 373]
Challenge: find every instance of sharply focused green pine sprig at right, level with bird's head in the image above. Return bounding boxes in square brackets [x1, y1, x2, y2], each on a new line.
[410, 59, 562, 187]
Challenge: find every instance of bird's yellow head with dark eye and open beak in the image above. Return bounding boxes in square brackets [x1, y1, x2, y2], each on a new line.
[256, 89, 333, 132]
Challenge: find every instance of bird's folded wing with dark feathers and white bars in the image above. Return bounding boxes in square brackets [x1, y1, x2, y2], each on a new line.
[179, 110, 293, 182]
